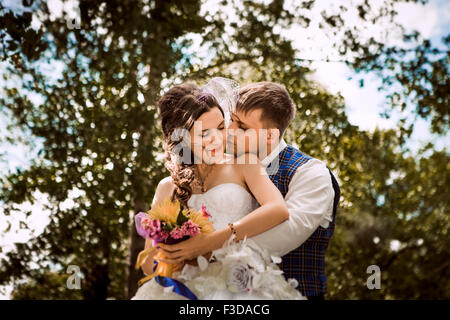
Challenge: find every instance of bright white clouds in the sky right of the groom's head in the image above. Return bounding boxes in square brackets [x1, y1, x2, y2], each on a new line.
[298, 0, 450, 151]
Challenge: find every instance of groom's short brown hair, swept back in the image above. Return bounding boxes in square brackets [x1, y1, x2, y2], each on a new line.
[236, 82, 295, 136]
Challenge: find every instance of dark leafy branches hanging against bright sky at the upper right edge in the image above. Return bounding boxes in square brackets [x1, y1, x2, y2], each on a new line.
[351, 31, 450, 134]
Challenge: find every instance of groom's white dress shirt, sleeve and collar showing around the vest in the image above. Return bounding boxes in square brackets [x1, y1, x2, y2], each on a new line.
[251, 139, 334, 256]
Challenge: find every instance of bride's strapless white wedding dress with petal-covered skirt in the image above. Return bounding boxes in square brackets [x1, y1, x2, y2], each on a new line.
[132, 183, 306, 300]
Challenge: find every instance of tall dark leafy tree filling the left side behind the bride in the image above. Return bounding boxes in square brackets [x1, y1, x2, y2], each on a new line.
[0, 1, 212, 299]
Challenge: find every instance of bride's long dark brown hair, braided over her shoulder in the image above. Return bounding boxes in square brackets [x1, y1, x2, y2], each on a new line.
[158, 84, 223, 207]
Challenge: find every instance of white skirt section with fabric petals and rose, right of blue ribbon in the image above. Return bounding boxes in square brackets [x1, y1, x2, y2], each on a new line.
[182, 237, 304, 299]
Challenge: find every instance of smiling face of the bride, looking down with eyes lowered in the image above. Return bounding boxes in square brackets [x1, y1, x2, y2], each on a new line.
[190, 107, 226, 164]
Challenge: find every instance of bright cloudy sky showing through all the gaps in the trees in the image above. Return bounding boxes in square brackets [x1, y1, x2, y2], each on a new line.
[0, 0, 450, 299]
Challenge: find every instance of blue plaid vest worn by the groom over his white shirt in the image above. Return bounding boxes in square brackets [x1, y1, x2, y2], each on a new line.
[269, 145, 340, 297]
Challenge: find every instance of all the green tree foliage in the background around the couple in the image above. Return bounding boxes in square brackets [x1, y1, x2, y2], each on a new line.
[0, 0, 450, 299]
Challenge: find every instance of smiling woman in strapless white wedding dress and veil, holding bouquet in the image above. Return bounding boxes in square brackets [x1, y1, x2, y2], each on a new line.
[132, 78, 305, 300]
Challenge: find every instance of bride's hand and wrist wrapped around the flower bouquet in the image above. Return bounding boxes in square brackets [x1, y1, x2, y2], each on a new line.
[157, 233, 215, 264]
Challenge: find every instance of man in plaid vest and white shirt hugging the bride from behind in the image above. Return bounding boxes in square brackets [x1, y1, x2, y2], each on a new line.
[227, 82, 340, 300]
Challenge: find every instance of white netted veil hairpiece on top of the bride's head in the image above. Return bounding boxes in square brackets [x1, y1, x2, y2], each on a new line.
[201, 77, 239, 126]
